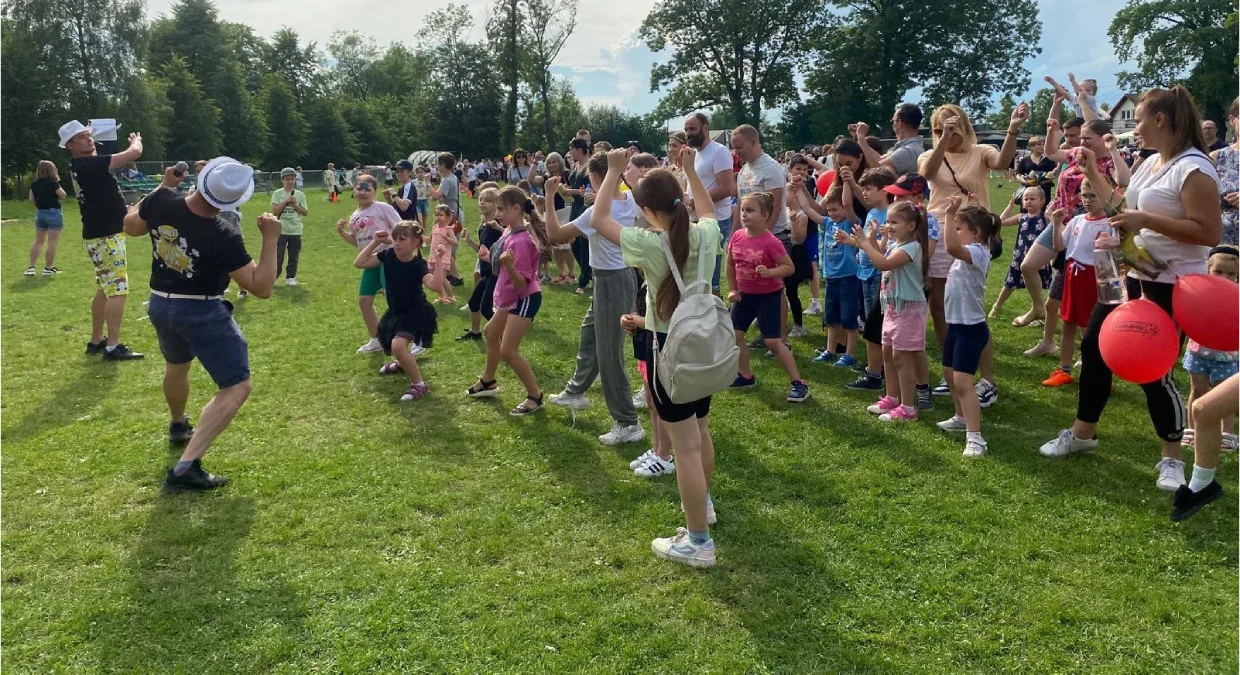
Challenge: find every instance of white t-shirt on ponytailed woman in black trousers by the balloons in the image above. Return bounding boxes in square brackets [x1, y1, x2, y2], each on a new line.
[1123, 148, 1219, 284]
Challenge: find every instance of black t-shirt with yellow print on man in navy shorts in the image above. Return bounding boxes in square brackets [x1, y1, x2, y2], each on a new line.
[138, 189, 253, 295]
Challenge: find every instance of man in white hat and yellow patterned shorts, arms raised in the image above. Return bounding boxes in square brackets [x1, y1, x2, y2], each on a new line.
[61, 119, 143, 361]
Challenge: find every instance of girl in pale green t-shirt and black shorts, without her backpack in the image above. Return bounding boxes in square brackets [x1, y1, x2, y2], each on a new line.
[590, 148, 720, 567]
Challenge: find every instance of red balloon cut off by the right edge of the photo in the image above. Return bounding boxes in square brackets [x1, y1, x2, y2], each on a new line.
[1171, 274, 1240, 351]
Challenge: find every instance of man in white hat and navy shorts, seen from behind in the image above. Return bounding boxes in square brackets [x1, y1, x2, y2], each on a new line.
[125, 158, 280, 490]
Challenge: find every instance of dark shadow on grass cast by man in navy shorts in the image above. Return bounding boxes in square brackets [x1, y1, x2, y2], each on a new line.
[88, 488, 308, 673]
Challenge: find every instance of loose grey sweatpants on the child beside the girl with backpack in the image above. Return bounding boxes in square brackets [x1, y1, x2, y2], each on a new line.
[564, 268, 637, 426]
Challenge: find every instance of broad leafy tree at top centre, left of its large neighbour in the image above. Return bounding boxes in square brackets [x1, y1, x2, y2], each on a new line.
[639, 0, 832, 124]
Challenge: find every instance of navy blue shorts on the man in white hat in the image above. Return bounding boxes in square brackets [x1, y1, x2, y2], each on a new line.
[146, 294, 249, 388]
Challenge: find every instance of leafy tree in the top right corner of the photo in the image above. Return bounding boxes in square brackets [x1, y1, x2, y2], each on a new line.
[1107, 0, 1240, 120]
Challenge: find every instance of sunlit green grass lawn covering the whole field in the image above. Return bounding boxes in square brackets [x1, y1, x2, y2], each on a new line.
[0, 186, 1240, 674]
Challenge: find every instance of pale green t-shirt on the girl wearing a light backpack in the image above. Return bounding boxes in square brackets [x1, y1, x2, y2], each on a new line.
[620, 218, 720, 333]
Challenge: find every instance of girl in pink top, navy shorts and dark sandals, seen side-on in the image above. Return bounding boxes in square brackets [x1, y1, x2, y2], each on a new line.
[465, 185, 547, 417]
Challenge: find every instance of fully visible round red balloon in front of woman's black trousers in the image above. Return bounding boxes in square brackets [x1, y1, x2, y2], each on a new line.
[1097, 298, 1179, 385]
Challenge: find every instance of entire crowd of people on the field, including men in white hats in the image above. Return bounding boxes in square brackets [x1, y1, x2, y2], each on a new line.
[33, 75, 1240, 567]
